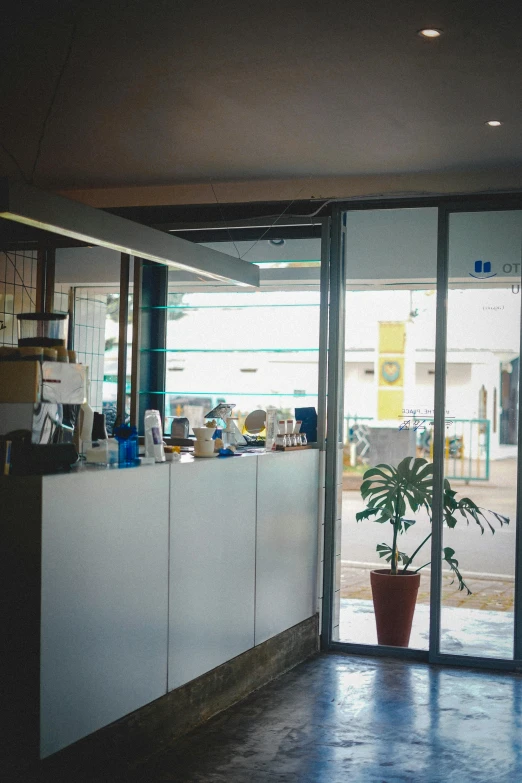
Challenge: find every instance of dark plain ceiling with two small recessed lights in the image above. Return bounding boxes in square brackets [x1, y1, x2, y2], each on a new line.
[0, 0, 522, 188]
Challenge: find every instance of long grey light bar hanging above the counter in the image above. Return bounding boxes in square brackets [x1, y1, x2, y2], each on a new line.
[0, 178, 259, 287]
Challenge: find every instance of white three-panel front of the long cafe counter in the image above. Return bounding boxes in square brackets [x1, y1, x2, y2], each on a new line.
[0, 449, 319, 757]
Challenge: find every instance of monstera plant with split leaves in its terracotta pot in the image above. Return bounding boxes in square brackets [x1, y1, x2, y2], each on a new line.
[355, 457, 509, 647]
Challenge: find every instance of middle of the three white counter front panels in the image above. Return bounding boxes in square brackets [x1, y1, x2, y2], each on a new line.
[169, 457, 258, 690]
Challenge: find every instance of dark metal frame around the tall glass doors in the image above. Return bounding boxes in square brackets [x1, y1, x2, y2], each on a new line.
[321, 194, 522, 671]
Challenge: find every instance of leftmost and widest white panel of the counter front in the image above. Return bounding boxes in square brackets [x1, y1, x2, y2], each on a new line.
[40, 466, 170, 757]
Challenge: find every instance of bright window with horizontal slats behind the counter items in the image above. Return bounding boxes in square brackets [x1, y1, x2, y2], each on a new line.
[161, 239, 320, 432]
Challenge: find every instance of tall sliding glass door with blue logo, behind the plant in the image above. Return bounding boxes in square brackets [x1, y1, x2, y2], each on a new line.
[323, 199, 522, 667]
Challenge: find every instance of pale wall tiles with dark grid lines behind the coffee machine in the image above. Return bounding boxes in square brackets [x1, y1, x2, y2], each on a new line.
[0, 250, 107, 411]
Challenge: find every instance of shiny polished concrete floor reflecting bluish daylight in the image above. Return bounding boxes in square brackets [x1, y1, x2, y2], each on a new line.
[126, 654, 522, 783]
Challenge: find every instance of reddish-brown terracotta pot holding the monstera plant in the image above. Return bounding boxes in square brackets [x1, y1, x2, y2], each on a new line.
[370, 569, 420, 647]
